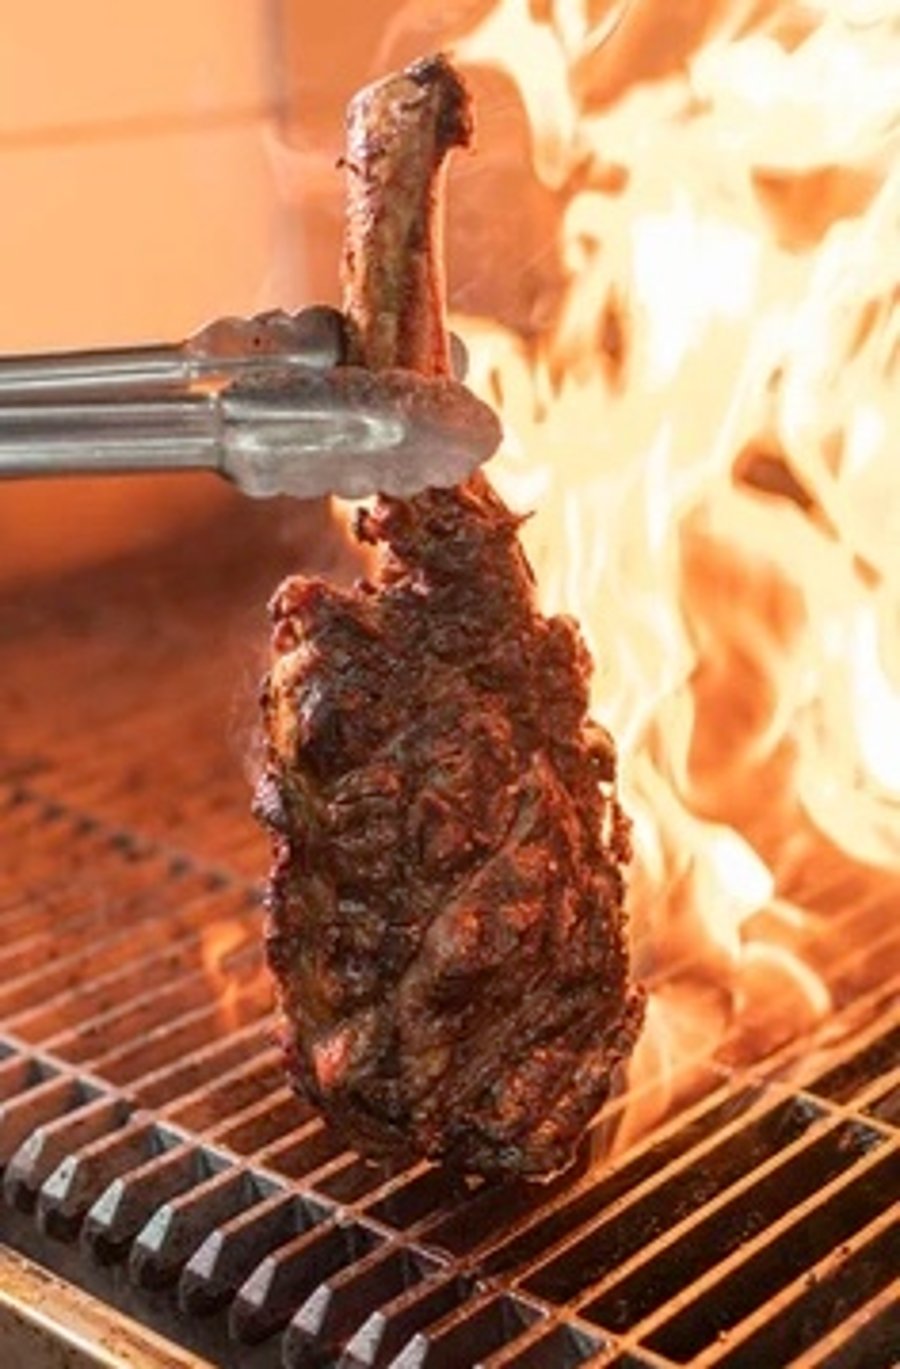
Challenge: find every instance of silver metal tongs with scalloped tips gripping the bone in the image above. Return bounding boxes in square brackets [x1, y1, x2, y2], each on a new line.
[0, 305, 500, 498]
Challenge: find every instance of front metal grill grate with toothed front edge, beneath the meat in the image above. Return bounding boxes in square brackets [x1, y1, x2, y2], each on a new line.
[0, 786, 900, 1369]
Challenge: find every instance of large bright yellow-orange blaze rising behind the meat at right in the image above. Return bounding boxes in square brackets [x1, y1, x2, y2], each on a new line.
[455, 0, 900, 1135]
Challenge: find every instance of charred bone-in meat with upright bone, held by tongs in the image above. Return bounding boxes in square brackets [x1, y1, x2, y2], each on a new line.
[256, 57, 642, 1176]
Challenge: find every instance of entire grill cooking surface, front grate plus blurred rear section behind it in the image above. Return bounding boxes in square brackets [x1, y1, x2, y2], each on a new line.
[0, 505, 900, 1369]
